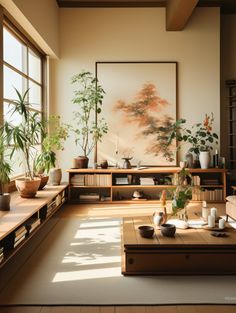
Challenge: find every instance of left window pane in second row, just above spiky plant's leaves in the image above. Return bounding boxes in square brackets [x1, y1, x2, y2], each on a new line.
[3, 65, 27, 99]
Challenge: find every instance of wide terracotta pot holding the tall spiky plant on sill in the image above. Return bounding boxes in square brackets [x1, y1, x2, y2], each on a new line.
[15, 177, 41, 198]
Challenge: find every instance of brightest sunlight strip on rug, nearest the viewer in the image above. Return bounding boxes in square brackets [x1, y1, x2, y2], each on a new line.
[52, 267, 121, 283]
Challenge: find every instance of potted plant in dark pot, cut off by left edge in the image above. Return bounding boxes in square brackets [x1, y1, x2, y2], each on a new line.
[0, 127, 12, 211]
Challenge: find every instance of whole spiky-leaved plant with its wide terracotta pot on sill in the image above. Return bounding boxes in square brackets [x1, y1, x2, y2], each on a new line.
[4, 89, 43, 198]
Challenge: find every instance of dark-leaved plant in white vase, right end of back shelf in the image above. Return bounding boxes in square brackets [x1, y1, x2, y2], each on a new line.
[160, 113, 218, 168]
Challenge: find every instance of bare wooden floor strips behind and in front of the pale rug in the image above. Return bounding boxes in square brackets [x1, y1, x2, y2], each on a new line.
[0, 204, 236, 313]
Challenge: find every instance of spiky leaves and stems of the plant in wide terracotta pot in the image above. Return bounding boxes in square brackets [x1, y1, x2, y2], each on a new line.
[4, 88, 43, 179]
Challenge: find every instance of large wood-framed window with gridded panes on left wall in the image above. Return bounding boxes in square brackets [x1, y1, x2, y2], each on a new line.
[3, 21, 43, 176]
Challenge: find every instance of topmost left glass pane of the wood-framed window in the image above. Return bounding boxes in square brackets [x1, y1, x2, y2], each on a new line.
[3, 27, 27, 73]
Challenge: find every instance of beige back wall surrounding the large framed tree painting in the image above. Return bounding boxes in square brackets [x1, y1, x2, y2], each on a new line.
[51, 8, 220, 168]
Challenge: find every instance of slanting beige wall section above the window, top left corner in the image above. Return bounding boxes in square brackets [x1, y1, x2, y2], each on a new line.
[0, 0, 59, 57]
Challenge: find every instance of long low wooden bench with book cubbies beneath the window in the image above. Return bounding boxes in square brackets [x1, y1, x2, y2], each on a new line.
[0, 184, 68, 268]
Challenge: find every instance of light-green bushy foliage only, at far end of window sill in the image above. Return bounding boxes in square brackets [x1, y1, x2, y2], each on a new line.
[35, 115, 69, 173]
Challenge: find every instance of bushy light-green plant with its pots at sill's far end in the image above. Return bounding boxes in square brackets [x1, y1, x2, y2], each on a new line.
[35, 115, 68, 189]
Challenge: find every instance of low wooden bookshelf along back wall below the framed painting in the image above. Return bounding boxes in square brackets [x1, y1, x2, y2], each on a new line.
[67, 167, 227, 203]
